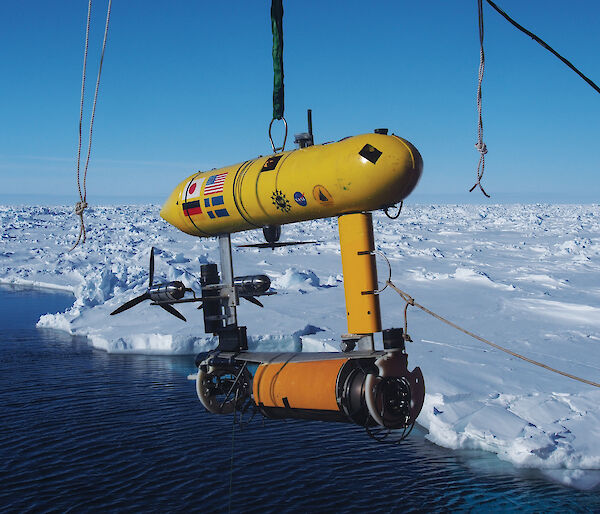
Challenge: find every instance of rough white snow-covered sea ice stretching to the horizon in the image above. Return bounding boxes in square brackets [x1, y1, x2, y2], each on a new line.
[0, 205, 600, 487]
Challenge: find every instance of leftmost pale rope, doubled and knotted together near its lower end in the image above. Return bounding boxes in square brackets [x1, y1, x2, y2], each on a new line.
[69, 0, 112, 248]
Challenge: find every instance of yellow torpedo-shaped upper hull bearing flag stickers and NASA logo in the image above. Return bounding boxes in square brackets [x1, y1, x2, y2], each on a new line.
[160, 134, 423, 237]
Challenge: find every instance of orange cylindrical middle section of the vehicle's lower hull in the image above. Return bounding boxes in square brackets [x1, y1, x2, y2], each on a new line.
[252, 359, 348, 411]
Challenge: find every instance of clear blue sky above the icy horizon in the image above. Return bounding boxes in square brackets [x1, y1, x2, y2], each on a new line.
[0, 0, 600, 203]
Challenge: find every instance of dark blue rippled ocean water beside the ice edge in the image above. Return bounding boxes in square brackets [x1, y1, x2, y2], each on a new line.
[0, 287, 600, 512]
